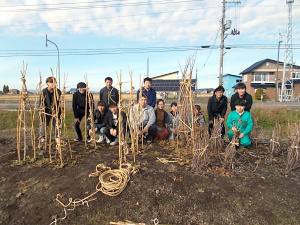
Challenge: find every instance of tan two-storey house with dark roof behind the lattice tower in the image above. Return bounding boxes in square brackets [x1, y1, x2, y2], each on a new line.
[240, 59, 300, 100]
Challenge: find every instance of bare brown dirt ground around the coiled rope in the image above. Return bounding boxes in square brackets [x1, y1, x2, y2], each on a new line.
[0, 129, 300, 225]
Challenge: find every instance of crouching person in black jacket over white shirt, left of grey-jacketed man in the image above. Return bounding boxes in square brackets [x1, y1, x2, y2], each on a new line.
[104, 103, 127, 145]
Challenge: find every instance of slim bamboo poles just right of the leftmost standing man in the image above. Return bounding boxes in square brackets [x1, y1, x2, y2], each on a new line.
[60, 75, 72, 159]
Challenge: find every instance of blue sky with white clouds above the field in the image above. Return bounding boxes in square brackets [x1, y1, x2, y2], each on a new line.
[0, 0, 300, 91]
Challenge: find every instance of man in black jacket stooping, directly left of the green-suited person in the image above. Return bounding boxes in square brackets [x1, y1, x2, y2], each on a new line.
[207, 85, 227, 137]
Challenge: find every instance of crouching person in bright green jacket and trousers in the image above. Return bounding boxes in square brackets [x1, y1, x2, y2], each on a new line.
[226, 98, 253, 146]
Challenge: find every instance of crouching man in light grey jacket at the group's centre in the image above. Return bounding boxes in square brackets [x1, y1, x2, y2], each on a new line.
[129, 94, 156, 144]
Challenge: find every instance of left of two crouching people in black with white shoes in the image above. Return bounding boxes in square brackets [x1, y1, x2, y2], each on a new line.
[88, 100, 108, 143]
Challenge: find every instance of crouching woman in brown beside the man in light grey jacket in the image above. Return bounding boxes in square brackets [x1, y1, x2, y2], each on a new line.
[153, 99, 169, 142]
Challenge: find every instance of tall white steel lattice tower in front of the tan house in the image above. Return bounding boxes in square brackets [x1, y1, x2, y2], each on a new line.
[280, 0, 294, 102]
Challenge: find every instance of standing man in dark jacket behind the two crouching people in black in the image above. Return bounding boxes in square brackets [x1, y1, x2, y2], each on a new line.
[99, 77, 119, 108]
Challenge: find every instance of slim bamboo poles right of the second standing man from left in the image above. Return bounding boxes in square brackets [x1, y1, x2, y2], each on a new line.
[84, 74, 97, 149]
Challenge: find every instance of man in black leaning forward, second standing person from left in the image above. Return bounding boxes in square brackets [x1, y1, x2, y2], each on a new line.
[72, 82, 94, 141]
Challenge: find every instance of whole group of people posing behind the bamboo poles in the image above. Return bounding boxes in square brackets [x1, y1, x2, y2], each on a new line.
[40, 77, 253, 146]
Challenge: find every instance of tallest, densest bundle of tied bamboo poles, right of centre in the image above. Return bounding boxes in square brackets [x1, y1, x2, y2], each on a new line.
[177, 57, 195, 154]
